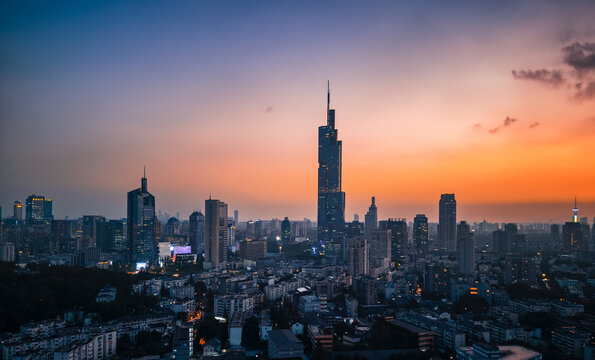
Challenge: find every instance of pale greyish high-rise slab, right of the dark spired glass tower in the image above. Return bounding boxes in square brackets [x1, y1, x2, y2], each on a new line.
[205, 199, 227, 267]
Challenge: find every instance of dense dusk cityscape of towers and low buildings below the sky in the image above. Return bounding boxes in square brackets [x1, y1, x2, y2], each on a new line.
[0, 84, 595, 360]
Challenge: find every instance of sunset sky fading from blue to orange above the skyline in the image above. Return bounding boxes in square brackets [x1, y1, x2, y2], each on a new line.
[0, 0, 595, 223]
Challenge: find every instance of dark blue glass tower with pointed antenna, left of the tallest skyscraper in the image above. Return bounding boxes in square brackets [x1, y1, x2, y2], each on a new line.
[127, 169, 157, 267]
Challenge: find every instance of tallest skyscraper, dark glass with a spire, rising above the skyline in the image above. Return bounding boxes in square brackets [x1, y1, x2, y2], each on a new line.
[318, 82, 345, 255]
